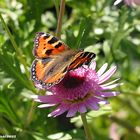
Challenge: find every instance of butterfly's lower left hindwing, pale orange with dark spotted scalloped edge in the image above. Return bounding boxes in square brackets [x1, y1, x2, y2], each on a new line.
[31, 53, 70, 88]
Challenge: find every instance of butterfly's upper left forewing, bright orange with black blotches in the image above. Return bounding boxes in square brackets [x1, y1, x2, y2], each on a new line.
[33, 32, 68, 58]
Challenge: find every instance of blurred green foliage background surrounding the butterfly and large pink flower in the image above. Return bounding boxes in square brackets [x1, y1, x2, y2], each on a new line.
[0, 0, 140, 140]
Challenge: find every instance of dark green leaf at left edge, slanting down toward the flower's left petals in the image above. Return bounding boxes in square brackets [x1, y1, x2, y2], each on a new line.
[0, 45, 34, 91]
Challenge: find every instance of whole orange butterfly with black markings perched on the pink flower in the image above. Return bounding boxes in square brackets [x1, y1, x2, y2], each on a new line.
[31, 32, 96, 89]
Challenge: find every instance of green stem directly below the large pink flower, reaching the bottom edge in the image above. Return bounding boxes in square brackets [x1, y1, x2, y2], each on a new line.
[81, 113, 93, 140]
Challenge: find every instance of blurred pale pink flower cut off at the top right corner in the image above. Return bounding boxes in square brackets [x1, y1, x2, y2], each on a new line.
[114, 0, 140, 6]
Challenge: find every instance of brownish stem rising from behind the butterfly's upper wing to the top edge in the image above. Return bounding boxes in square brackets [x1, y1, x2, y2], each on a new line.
[56, 0, 65, 38]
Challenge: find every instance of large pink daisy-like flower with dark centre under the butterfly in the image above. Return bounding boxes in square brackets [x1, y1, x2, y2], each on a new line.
[32, 62, 121, 117]
